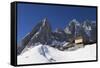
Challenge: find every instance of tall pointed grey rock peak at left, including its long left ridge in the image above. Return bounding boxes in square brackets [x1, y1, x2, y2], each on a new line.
[18, 18, 51, 54]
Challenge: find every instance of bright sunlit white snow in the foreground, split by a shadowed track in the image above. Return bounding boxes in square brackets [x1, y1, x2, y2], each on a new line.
[18, 44, 96, 64]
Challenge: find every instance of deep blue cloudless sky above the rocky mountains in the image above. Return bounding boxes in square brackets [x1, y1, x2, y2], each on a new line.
[17, 3, 96, 41]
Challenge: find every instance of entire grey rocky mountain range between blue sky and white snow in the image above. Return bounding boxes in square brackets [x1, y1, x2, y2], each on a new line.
[17, 18, 96, 55]
